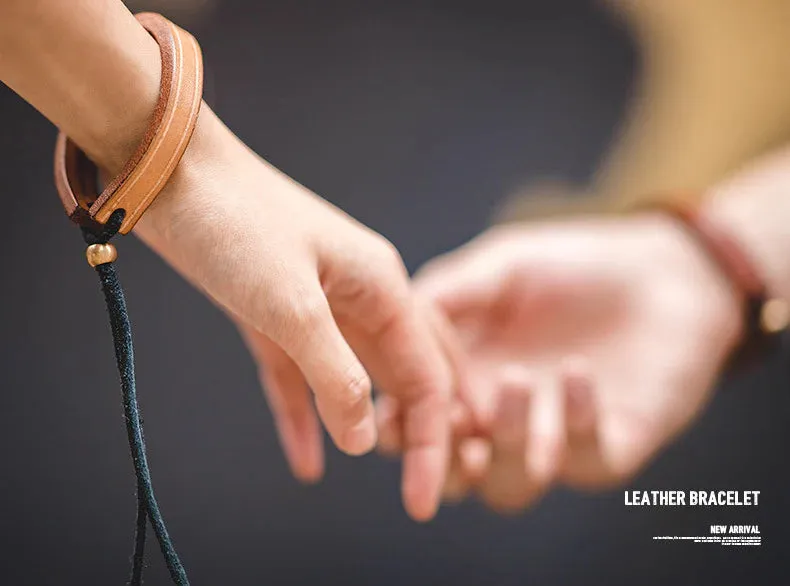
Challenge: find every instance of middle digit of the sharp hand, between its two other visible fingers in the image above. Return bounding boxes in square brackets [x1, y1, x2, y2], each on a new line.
[264, 282, 376, 455]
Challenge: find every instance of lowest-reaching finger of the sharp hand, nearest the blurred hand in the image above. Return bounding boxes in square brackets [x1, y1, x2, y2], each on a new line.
[329, 242, 453, 521]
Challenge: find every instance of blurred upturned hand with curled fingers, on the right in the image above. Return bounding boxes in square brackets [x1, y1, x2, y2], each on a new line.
[379, 215, 742, 510]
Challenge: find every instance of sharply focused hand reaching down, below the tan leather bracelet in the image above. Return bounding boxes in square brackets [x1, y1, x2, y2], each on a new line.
[135, 105, 452, 519]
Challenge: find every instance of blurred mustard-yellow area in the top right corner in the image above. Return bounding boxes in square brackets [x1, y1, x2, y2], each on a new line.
[594, 0, 790, 205]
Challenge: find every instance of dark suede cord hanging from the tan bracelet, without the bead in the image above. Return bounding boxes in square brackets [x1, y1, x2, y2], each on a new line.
[82, 210, 189, 586]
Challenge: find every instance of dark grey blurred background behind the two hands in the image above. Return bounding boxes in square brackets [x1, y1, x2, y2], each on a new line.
[0, 0, 790, 586]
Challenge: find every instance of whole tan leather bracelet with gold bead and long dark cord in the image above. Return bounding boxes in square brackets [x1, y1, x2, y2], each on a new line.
[55, 13, 203, 586]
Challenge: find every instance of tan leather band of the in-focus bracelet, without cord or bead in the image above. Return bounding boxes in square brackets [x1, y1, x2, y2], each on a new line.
[55, 12, 203, 234]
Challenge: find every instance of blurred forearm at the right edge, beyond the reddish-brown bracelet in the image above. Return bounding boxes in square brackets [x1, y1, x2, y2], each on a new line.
[704, 147, 790, 301]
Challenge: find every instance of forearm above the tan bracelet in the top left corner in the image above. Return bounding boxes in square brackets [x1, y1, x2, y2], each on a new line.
[0, 0, 161, 172]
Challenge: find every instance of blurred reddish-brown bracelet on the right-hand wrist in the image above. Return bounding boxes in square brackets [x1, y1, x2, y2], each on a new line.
[639, 201, 790, 367]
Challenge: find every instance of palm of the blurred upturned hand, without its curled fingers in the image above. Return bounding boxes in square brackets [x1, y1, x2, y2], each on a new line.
[418, 214, 736, 486]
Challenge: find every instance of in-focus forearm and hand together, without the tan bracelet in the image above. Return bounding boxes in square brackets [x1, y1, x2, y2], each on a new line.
[0, 0, 454, 520]
